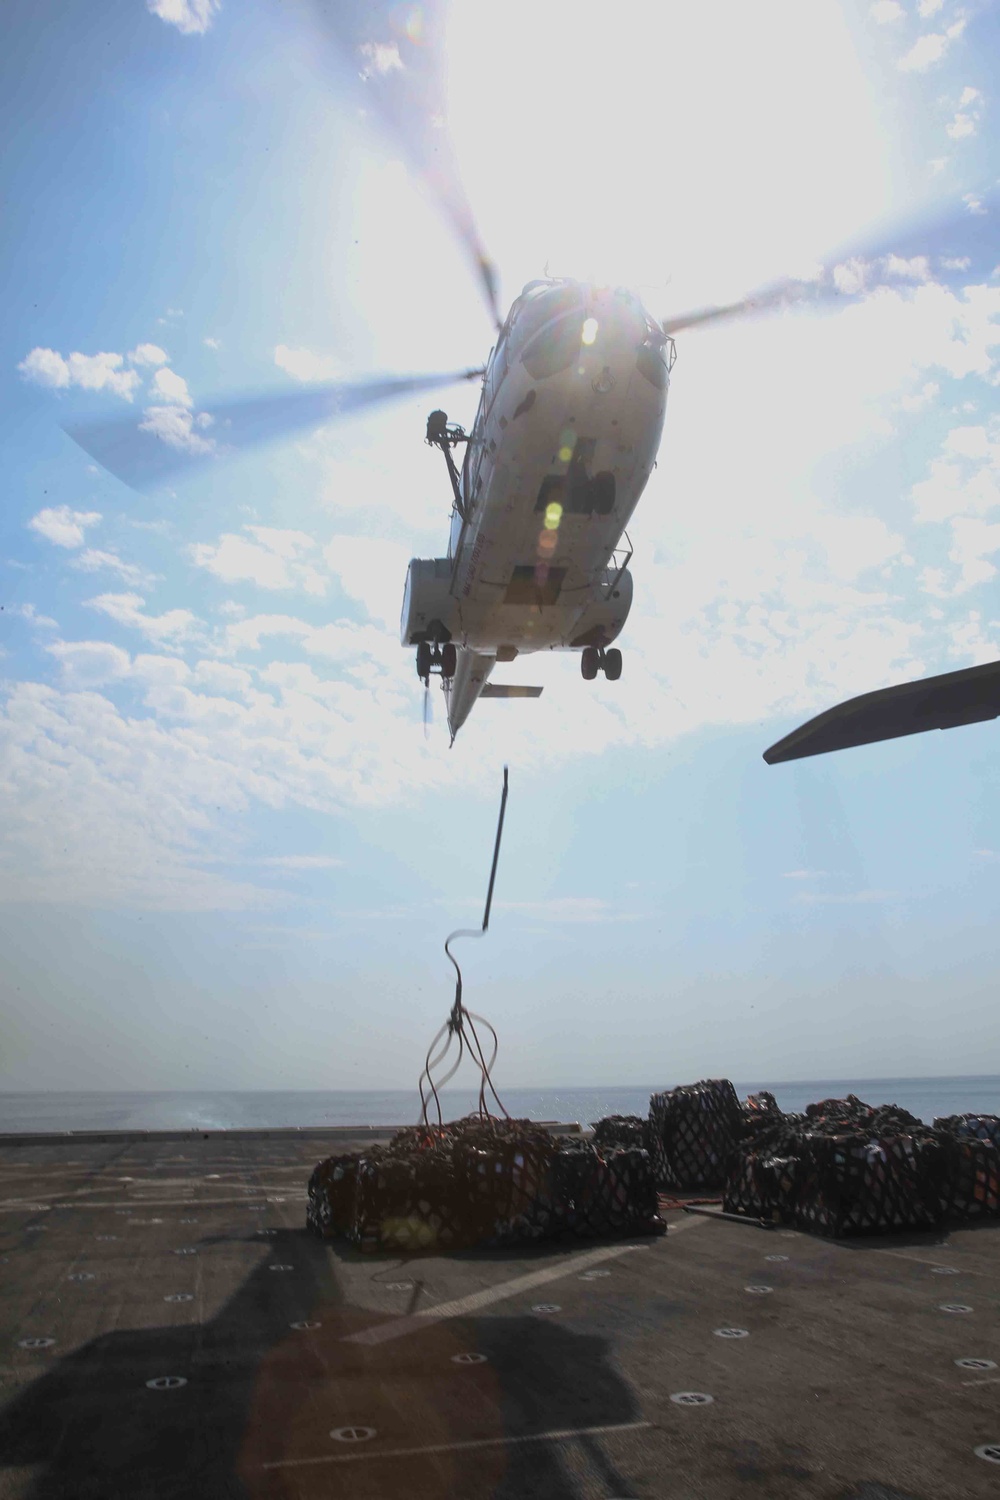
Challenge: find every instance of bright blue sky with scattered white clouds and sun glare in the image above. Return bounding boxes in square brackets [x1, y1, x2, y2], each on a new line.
[0, 0, 1000, 1091]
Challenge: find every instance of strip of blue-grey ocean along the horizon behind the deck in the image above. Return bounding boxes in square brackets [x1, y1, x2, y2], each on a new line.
[0, 1074, 1000, 1133]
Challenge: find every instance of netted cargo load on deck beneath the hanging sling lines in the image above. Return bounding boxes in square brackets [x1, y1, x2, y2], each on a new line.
[306, 1118, 666, 1253]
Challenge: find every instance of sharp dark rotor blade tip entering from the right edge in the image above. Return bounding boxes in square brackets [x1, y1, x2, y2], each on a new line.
[765, 662, 1000, 765]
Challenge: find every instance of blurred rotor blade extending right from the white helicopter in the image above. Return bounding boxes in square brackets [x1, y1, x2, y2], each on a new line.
[663, 191, 1000, 335]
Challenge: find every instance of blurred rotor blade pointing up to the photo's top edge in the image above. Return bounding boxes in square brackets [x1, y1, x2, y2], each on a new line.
[296, 0, 501, 329]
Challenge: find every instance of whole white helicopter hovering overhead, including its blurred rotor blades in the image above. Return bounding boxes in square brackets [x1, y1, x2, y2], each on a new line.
[67, 0, 991, 744]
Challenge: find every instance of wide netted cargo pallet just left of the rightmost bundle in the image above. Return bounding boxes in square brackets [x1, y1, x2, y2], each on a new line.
[792, 1131, 945, 1236]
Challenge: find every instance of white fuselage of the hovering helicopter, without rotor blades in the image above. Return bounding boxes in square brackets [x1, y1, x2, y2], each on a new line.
[402, 281, 673, 737]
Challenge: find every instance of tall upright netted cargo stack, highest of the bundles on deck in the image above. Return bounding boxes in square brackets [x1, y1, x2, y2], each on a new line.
[649, 1079, 744, 1188]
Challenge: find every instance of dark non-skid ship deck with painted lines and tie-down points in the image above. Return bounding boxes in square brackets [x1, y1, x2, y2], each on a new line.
[0, 1134, 1000, 1500]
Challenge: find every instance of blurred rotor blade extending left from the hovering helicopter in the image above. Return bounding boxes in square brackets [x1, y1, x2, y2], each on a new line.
[64, 371, 483, 489]
